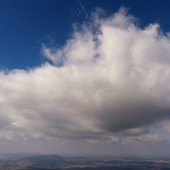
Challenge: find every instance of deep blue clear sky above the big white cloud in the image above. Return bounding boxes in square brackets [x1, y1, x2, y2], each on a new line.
[0, 0, 170, 69]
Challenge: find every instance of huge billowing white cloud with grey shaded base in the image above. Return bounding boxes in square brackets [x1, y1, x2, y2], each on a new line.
[0, 9, 170, 142]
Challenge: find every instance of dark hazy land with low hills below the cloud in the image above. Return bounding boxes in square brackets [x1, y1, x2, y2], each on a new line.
[0, 154, 170, 170]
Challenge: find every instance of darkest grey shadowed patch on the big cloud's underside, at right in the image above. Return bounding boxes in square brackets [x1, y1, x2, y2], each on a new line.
[99, 101, 170, 132]
